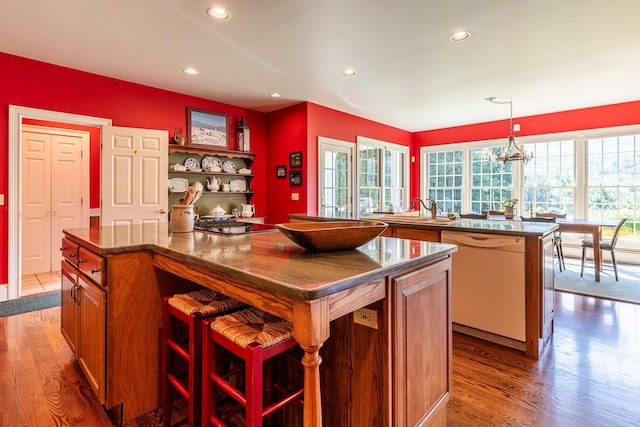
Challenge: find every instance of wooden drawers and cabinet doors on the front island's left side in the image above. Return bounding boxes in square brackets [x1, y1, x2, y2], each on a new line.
[60, 244, 106, 404]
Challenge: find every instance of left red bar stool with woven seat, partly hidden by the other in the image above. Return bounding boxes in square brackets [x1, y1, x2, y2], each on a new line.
[161, 289, 244, 427]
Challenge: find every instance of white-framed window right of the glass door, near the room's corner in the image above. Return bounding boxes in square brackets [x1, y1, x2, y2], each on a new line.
[358, 136, 409, 214]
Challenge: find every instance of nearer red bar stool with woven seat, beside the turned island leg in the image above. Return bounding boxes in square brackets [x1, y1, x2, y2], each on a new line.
[202, 308, 304, 427]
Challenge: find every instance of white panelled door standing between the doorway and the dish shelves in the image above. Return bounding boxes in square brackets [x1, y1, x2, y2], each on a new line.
[100, 126, 169, 227]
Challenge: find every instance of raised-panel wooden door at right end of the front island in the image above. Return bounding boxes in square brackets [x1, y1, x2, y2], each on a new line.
[391, 259, 452, 426]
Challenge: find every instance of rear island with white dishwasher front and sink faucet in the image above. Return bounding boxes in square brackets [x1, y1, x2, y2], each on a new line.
[289, 212, 558, 359]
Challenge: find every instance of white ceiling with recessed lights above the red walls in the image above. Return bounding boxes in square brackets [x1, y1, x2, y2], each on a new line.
[0, 0, 640, 131]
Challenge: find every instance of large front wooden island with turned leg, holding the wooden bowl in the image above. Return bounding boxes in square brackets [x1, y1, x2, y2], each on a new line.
[62, 224, 456, 427]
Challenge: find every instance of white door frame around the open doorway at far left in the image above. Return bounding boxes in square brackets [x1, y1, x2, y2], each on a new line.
[7, 105, 112, 300]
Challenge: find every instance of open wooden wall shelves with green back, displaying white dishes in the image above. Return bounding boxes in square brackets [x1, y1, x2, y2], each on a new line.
[169, 146, 255, 215]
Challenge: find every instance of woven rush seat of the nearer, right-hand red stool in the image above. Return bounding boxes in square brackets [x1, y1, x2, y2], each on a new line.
[211, 308, 293, 348]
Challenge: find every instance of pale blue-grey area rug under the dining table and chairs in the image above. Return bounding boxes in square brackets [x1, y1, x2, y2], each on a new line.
[555, 259, 640, 304]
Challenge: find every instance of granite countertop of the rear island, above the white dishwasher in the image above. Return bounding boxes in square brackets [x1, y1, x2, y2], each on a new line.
[289, 214, 558, 237]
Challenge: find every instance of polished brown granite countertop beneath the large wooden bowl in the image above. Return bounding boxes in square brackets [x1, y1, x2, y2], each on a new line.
[64, 224, 457, 300]
